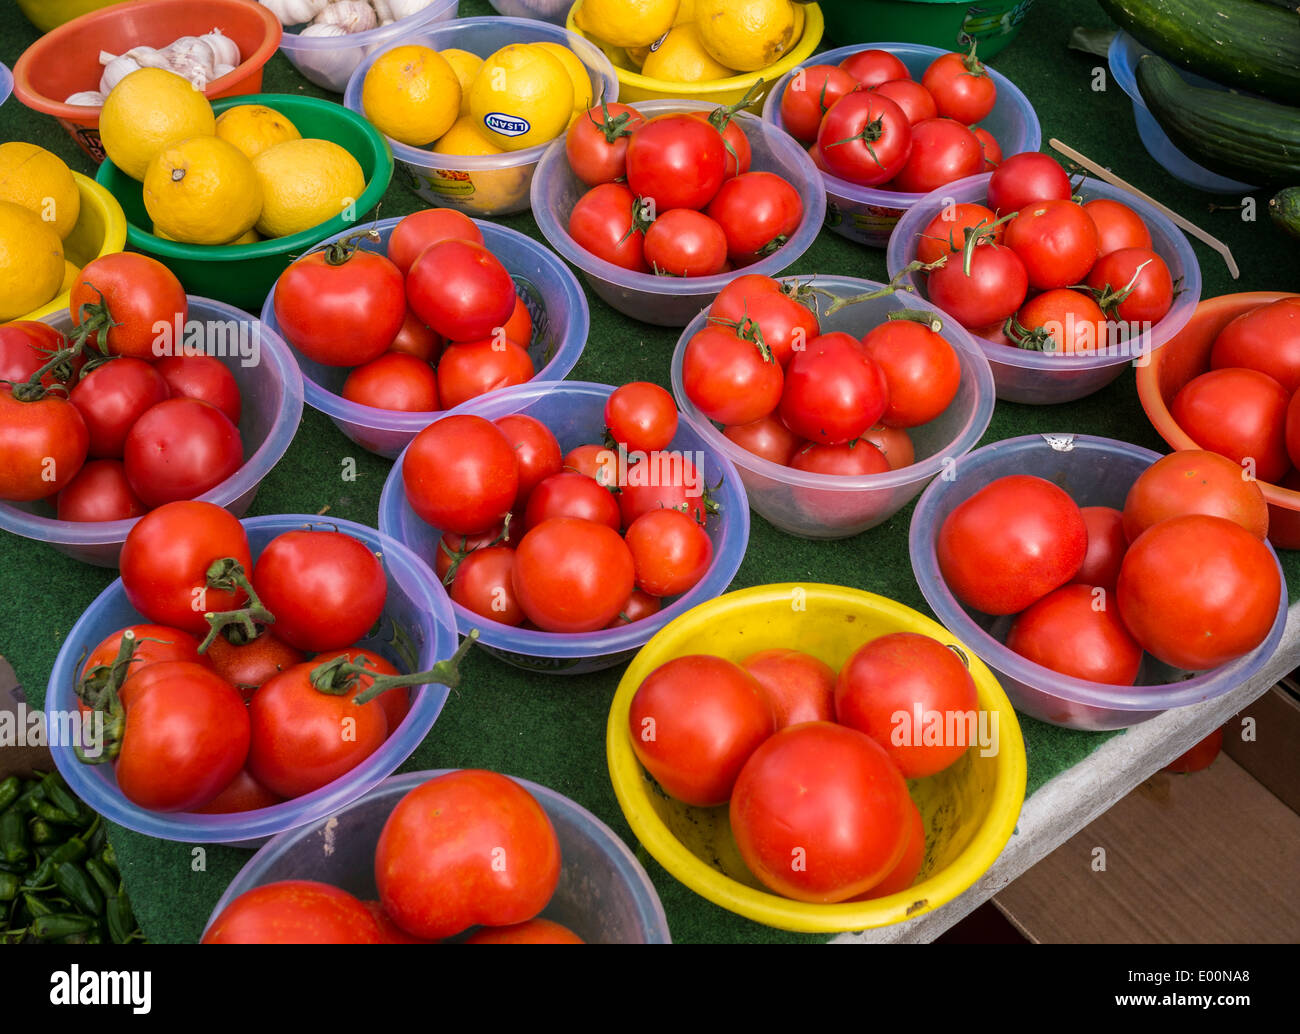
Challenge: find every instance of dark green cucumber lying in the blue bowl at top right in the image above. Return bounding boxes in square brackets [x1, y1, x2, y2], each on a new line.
[1138, 53, 1300, 186]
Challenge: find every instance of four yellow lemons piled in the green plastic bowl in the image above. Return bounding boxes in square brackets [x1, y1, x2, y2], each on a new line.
[99, 68, 365, 245]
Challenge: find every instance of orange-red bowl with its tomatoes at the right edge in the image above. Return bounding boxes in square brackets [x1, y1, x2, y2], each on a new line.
[1138, 291, 1300, 549]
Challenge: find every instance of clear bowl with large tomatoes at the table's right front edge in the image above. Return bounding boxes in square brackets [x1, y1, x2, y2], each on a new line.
[909, 434, 1287, 731]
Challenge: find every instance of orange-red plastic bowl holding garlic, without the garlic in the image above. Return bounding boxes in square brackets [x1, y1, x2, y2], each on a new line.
[13, 0, 283, 163]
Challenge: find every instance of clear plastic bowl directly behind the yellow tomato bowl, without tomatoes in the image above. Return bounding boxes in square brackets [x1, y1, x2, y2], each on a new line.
[672, 276, 993, 538]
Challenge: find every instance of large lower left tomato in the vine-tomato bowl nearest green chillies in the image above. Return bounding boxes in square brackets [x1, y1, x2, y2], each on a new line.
[114, 661, 250, 812]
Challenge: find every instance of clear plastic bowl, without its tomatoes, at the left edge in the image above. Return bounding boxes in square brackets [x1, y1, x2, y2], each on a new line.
[0, 295, 303, 567]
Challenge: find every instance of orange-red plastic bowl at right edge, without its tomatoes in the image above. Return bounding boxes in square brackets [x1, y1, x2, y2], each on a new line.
[1138, 291, 1300, 549]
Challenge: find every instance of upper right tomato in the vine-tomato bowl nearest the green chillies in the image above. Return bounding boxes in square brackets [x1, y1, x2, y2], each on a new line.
[252, 531, 389, 652]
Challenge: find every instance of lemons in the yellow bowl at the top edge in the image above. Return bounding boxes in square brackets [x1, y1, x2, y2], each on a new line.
[573, 0, 805, 82]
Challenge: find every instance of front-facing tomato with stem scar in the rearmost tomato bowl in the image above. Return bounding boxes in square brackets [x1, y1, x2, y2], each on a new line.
[816, 90, 911, 187]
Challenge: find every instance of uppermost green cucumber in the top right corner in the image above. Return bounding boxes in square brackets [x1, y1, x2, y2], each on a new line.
[1099, 0, 1300, 104]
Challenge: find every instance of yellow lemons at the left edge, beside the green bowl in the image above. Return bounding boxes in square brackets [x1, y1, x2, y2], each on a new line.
[0, 140, 81, 323]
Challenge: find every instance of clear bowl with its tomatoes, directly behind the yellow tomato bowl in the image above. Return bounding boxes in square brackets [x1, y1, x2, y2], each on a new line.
[671, 274, 993, 538]
